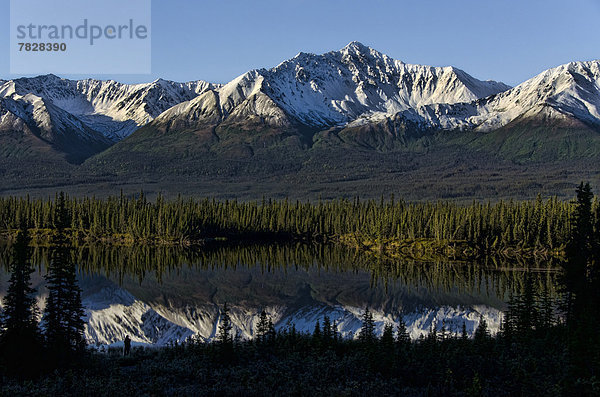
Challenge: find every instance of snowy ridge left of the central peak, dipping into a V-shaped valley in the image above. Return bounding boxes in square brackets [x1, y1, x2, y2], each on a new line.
[0, 75, 219, 141]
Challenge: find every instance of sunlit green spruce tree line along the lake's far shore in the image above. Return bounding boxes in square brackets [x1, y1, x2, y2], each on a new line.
[0, 189, 600, 250]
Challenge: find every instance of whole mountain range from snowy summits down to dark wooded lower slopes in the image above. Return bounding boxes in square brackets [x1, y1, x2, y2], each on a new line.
[0, 42, 600, 199]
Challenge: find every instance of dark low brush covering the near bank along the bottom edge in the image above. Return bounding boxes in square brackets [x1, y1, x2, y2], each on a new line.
[0, 320, 576, 396]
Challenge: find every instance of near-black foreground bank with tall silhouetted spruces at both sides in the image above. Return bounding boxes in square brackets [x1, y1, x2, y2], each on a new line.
[0, 184, 600, 396]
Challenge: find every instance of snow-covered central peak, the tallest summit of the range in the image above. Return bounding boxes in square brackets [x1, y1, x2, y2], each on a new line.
[151, 42, 510, 128]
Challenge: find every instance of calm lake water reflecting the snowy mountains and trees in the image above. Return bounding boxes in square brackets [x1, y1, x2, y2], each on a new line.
[0, 240, 558, 345]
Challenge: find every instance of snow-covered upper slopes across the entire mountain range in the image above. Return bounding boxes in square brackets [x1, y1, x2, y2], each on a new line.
[5, 42, 600, 148]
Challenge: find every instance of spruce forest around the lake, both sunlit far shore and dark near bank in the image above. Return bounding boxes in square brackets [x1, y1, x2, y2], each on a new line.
[0, 184, 600, 396]
